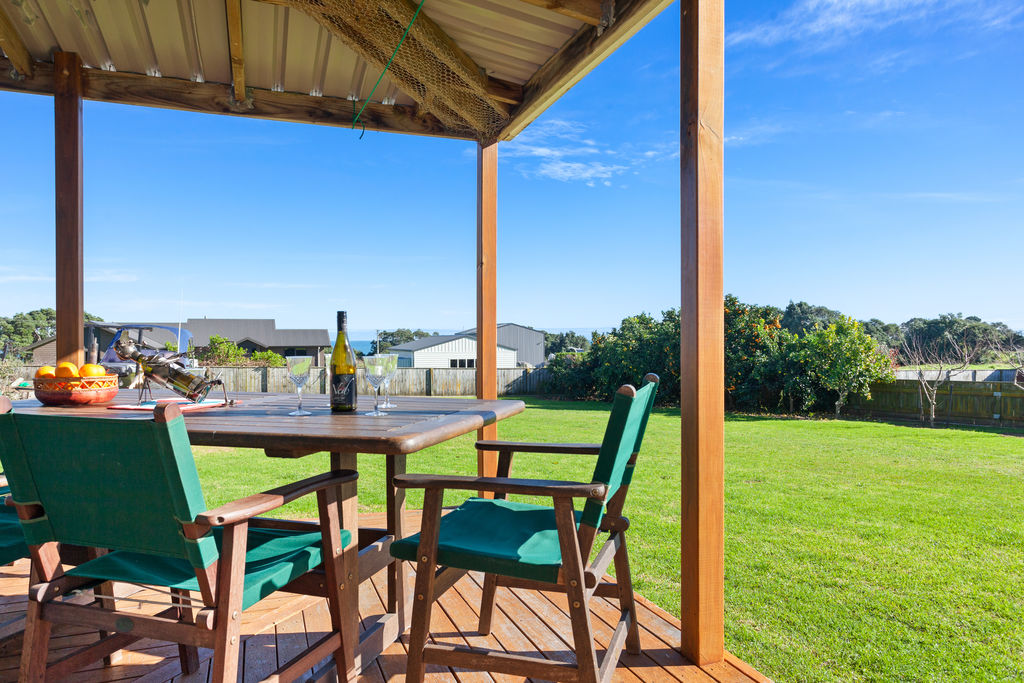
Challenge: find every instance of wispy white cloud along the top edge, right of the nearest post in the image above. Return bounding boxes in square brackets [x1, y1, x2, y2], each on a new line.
[726, 0, 1024, 49]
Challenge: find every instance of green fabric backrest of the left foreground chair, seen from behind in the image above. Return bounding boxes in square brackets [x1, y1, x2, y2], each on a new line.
[0, 403, 217, 568]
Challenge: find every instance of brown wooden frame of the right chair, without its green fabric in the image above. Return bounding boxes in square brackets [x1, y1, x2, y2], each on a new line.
[394, 375, 657, 683]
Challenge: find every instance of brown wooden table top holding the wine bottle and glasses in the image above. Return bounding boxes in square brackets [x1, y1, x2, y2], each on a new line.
[13, 390, 525, 457]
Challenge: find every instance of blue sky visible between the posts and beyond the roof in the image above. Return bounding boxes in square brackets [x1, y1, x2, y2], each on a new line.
[0, 0, 1024, 337]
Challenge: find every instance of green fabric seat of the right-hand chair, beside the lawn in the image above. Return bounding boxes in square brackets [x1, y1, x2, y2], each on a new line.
[391, 498, 581, 584]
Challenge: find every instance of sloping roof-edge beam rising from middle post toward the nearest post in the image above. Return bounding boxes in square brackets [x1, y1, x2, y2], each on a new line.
[500, 0, 672, 140]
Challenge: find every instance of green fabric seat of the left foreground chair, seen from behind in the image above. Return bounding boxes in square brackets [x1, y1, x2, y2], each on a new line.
[68, 527, 352, 609]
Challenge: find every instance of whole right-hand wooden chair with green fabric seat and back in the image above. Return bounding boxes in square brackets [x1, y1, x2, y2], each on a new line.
[391, 375, 658, 681]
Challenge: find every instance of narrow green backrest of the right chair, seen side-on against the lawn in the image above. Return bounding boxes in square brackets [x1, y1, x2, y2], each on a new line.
[581, 374, 658, 528]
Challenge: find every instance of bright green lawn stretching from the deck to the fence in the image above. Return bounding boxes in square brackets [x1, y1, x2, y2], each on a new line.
[196, 398, 1024, 681]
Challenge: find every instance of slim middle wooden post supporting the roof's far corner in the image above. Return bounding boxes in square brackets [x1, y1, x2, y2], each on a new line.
[476, 142, 498, 481]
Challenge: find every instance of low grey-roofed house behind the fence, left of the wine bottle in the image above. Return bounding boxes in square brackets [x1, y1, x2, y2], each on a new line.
[27, 317, 331, 366]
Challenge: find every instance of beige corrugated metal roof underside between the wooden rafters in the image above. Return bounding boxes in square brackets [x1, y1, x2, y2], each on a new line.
[0, 0, 583, 100]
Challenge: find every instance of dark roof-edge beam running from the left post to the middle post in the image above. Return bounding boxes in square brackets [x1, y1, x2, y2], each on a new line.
[0, 57, 466, 139]
